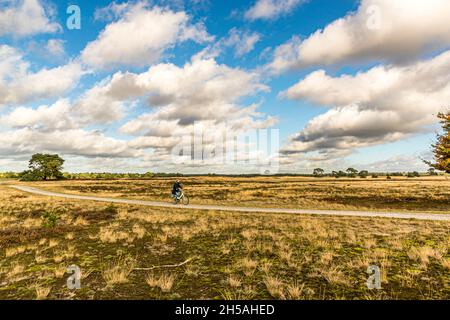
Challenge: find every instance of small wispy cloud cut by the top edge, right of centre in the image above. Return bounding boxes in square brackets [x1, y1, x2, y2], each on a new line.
[245, 0, 305, 20]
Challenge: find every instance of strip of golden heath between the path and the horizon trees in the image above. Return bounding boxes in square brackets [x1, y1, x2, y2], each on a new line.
[15, 176, 450, 213]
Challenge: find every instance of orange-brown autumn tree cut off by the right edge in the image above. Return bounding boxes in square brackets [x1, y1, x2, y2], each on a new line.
[425, 111, 450, 173]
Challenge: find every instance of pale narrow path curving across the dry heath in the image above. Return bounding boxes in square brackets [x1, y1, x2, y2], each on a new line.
[10, 186, 450, 221]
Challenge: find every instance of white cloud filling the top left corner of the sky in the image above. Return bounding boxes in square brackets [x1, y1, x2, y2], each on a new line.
[0, 0, 61, 37]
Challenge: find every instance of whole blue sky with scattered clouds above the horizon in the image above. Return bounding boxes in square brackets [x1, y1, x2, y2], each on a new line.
[0, 0, 450, 173]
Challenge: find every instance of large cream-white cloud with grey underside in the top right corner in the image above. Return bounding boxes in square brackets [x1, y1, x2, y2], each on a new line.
[270, 0, 450, 73]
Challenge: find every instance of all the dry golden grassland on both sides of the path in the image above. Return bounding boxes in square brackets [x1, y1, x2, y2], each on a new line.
[0, 177, 450, 299]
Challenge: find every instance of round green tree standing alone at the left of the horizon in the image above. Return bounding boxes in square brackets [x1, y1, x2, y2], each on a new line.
[21, 153, 64, 180]
